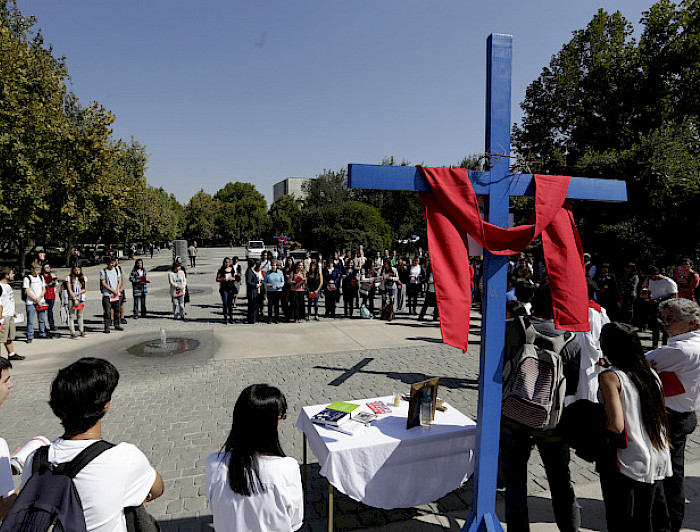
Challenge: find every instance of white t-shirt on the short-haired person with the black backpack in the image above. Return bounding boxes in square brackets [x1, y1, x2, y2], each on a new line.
[22, 438, 156, 532]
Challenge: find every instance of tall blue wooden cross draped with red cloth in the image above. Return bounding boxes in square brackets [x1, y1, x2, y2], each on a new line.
[348, 34, 627, 532]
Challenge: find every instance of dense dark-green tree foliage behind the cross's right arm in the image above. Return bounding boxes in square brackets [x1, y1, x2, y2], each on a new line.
[513, 0, 700, 262]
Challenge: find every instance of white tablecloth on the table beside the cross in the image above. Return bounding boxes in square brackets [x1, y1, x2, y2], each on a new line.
[296, 397, 476, 510]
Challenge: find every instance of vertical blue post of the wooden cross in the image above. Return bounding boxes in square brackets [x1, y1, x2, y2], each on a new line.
[463, 33, 513, 532]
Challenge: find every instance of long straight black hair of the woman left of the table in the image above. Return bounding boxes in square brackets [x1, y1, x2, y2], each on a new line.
[224, 384, 287, 497]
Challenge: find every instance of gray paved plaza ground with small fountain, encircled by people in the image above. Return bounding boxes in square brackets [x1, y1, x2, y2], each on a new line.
[5, 248, 700, 531]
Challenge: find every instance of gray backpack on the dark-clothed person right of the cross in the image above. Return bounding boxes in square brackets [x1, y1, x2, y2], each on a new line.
[501, 316, 575, 430]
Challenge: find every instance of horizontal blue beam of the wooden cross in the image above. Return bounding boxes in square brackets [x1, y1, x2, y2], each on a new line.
[348, 164, 627, 202]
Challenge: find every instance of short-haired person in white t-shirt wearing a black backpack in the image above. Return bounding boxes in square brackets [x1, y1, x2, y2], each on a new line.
[11, 358, 163, 532]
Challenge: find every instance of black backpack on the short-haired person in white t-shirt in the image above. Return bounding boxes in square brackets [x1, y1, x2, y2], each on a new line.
[0, 440, 114, 532]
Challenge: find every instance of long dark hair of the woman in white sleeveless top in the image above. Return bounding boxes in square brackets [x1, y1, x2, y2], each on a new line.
[600, 322, 668, 449]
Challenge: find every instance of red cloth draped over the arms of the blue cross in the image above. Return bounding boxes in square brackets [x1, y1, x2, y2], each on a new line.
[418, 166, 590, 351]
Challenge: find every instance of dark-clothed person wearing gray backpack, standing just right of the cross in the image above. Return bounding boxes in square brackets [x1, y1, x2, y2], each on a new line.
[501, 282, 581, 532]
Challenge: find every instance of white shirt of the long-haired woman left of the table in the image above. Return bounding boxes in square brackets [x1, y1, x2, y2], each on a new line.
[206, 453, 304, 532]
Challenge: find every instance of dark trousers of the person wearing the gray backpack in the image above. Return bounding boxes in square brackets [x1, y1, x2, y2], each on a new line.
[501, 419, 584, 532]
